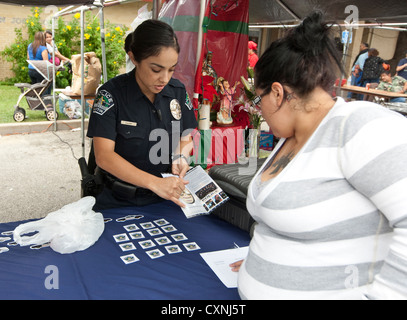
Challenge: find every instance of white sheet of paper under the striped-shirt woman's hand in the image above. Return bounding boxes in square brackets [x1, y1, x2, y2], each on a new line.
[201, 247, 249, 288]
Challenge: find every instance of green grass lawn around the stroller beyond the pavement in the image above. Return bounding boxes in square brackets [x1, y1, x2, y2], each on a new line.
[0, 85, 69, 123]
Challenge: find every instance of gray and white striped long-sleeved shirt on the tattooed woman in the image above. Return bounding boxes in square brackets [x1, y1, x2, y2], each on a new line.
[239, 98, 407, 299]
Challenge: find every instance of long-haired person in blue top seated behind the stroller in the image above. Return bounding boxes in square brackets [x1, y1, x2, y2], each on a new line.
[27, 31, 49, 84]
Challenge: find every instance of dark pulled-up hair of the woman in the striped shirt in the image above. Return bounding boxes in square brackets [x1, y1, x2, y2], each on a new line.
[255, 11, 342, 96]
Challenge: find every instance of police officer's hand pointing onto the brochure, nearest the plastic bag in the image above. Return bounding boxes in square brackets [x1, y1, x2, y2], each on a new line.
[152, 177, 189, 208]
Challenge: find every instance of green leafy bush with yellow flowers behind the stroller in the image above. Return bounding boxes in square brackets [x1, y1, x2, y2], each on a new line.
[0, 7, 128, 88]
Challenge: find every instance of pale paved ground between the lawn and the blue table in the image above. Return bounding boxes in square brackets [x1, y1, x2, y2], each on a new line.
[0, 120, 89, 223]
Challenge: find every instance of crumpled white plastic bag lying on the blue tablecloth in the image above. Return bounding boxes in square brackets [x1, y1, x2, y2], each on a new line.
[14, 197, 105, 254]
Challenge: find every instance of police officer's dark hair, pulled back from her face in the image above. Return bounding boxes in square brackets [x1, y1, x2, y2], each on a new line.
[130, 19, 180, 62]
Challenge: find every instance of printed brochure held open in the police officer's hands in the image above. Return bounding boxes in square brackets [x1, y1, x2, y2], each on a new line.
[162, 166, 229, 218]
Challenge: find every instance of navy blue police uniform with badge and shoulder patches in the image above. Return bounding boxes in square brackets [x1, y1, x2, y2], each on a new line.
[87, 69, 197, 210]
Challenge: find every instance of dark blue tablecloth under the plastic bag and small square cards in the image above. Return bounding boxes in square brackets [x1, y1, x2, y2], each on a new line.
[0, 202, 250, 300]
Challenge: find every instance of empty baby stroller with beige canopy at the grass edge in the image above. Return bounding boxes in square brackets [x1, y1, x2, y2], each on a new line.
[13, 60, 63, 122]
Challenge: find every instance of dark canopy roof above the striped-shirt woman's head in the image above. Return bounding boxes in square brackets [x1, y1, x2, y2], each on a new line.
[244, 0, 407, 104]
